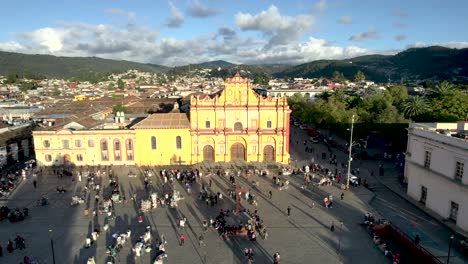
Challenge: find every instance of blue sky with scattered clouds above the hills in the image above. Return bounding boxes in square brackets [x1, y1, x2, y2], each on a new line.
[0, 0, 468, 67]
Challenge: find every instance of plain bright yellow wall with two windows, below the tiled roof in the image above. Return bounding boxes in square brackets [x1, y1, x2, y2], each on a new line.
[135, 128, 192, 166]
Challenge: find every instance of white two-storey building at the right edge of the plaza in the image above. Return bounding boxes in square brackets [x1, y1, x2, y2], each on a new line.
[405, 121, 468, 231]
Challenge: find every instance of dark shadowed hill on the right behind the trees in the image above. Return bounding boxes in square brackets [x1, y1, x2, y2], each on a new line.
[274, 46, 468, 81]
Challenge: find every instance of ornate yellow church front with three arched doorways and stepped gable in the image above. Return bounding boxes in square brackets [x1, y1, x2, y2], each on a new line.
[190, 74, 291, 163]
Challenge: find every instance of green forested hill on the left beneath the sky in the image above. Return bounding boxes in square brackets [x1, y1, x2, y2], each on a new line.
[0, 51, 168, 78]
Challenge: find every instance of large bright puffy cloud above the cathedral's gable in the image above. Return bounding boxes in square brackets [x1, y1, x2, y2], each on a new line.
[234, 5, 322, 48]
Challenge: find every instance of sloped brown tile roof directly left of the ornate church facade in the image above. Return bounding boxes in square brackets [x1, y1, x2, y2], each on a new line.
[132, 113, 190, 129]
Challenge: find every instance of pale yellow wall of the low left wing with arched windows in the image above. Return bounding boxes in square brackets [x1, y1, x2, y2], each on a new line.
[33, 129, 138, 166]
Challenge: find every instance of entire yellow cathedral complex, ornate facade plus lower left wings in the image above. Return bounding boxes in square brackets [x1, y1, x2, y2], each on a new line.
[33, 74, 291, 166]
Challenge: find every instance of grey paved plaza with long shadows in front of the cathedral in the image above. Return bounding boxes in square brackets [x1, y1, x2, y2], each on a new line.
[0, 124, 461, 264]
